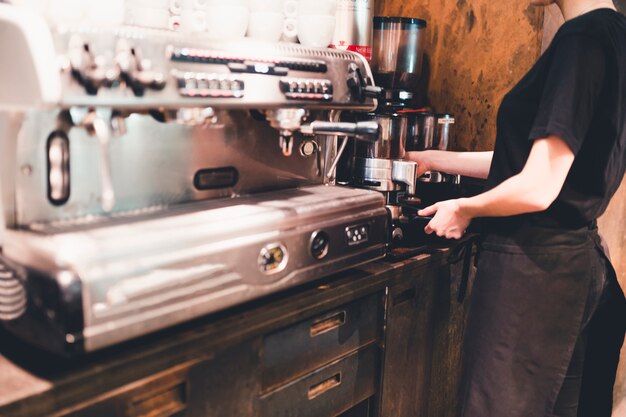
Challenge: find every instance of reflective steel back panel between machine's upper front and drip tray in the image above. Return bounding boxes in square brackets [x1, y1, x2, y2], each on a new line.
[12, 110, 325, 226]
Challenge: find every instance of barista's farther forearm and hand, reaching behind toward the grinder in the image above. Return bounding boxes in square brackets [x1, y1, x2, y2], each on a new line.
[406, 150, 493, 179]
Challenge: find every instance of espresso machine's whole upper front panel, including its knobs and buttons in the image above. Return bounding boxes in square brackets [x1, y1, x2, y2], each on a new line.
[0, 24, 377, 109]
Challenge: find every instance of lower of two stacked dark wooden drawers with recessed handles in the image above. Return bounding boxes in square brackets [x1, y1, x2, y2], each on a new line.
[261, 345, 378, 417]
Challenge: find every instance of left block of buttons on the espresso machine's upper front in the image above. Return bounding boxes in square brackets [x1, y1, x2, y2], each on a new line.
[174, 71, 245, 98]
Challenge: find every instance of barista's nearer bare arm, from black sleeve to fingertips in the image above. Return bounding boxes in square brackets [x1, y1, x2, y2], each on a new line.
[419, 135, 575, 239]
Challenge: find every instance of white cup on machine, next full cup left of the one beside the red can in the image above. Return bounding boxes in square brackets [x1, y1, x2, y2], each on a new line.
[248, 0, 285, 42]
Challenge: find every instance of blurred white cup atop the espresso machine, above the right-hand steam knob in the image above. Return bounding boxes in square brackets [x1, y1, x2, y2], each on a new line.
[124, 0, 182, 30]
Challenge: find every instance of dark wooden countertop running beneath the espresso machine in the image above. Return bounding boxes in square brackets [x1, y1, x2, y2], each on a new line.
[0, 250, 445, 417]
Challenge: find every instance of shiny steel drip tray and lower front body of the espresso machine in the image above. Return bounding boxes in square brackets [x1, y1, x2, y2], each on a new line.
[4, 186, 388, 350]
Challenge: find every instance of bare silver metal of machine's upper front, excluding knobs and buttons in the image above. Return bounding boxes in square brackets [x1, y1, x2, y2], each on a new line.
[46, 27, 376, 111]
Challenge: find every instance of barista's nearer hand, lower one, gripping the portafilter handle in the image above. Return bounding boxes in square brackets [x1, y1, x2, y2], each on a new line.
[417, 200, 472, 239]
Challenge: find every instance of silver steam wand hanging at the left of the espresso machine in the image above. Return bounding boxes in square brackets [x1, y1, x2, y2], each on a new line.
[82, 110, 115, 213]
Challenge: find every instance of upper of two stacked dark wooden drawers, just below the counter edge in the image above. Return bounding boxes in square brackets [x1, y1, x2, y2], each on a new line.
[262, 294, 382, 392]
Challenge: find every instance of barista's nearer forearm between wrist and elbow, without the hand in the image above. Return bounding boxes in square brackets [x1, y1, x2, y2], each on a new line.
[459, 174, 559, 218]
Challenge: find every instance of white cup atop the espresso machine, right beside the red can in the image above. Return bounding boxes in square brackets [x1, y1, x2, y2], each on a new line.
[297, 0, 337, 48]
